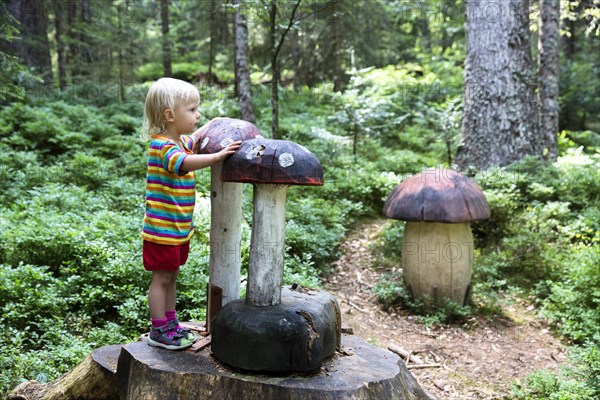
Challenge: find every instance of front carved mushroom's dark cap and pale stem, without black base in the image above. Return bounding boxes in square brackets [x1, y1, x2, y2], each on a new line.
[222, 138, 323, 306]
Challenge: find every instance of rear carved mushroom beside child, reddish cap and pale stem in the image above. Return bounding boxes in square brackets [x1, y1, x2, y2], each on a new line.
[194, 118, 262, 330]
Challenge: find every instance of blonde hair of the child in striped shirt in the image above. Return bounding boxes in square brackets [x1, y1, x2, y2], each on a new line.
[142, 78, 200, 140]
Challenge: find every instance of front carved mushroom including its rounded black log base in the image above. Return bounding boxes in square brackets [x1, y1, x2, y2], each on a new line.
[211, 139, 341, 372]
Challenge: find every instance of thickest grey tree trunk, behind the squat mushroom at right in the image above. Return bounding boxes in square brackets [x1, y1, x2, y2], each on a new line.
[455, 0, 541, 169]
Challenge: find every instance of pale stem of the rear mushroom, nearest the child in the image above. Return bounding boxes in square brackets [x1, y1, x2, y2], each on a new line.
[207, 162, 242, 321]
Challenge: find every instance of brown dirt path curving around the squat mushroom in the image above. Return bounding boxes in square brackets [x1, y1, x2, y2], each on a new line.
[325, 220, 566, 400]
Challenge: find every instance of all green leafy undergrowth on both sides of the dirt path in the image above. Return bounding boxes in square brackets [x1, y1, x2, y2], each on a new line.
[0, 66, 600, 394]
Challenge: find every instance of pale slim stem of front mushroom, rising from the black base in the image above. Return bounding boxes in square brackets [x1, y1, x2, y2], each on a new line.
[246, 183, 287, 306]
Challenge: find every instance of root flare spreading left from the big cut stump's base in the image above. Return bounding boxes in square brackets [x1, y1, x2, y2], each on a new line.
[8, 344, 123, 400]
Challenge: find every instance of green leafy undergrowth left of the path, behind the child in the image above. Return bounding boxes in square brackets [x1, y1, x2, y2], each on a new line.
[0, 69, 450, 394]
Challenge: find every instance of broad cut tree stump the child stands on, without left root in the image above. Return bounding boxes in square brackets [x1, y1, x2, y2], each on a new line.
[117, 336, 429, 400]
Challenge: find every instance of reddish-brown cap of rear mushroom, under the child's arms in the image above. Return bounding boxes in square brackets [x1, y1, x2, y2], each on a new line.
[193, 118, 262, 154]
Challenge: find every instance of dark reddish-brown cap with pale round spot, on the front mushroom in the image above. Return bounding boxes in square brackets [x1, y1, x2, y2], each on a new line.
[221, 138, 324, 186]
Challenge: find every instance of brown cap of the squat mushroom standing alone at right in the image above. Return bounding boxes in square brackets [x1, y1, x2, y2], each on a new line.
[383, 168, 490, 223]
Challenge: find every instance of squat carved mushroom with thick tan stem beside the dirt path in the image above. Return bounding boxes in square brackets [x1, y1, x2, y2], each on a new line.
[383, 169, 490, 305]
